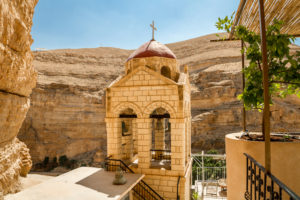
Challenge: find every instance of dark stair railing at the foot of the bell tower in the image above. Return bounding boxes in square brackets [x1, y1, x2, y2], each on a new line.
[105, 157, 164, 200]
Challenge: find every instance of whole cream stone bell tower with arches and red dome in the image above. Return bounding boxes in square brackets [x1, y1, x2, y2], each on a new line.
[105, 23, 192, 199]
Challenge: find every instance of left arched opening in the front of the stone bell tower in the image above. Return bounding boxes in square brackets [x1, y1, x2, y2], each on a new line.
[119, 108, 138, 161]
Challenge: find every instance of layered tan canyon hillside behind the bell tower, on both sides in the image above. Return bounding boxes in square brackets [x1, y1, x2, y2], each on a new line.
[19, 34, 300, 162]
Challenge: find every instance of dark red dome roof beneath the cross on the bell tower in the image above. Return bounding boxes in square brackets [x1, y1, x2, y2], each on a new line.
[127, 40, 176, 61]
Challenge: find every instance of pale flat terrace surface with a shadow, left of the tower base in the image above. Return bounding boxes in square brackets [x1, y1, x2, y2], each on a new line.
[4, 167, 144, 200]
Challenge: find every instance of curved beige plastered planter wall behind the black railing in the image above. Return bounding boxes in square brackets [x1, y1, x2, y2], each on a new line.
[225, 133, 300, 200]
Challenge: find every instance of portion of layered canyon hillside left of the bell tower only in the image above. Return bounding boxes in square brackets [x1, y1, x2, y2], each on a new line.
[19, 48, 128, 162]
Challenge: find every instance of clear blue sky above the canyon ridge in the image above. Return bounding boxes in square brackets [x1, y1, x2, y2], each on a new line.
[32, 0, 298, 50]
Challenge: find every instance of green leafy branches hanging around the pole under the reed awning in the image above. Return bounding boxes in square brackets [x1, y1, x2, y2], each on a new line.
[216, 16, 300, 110]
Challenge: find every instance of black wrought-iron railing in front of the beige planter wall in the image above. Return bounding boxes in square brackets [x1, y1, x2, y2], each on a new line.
[244, 153, 300, 200]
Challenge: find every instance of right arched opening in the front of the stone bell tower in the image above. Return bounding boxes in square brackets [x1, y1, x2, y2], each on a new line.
[150, 108, 171, 169]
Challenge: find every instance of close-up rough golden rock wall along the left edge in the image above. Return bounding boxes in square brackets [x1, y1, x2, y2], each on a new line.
[0, 0, 37, 195]
